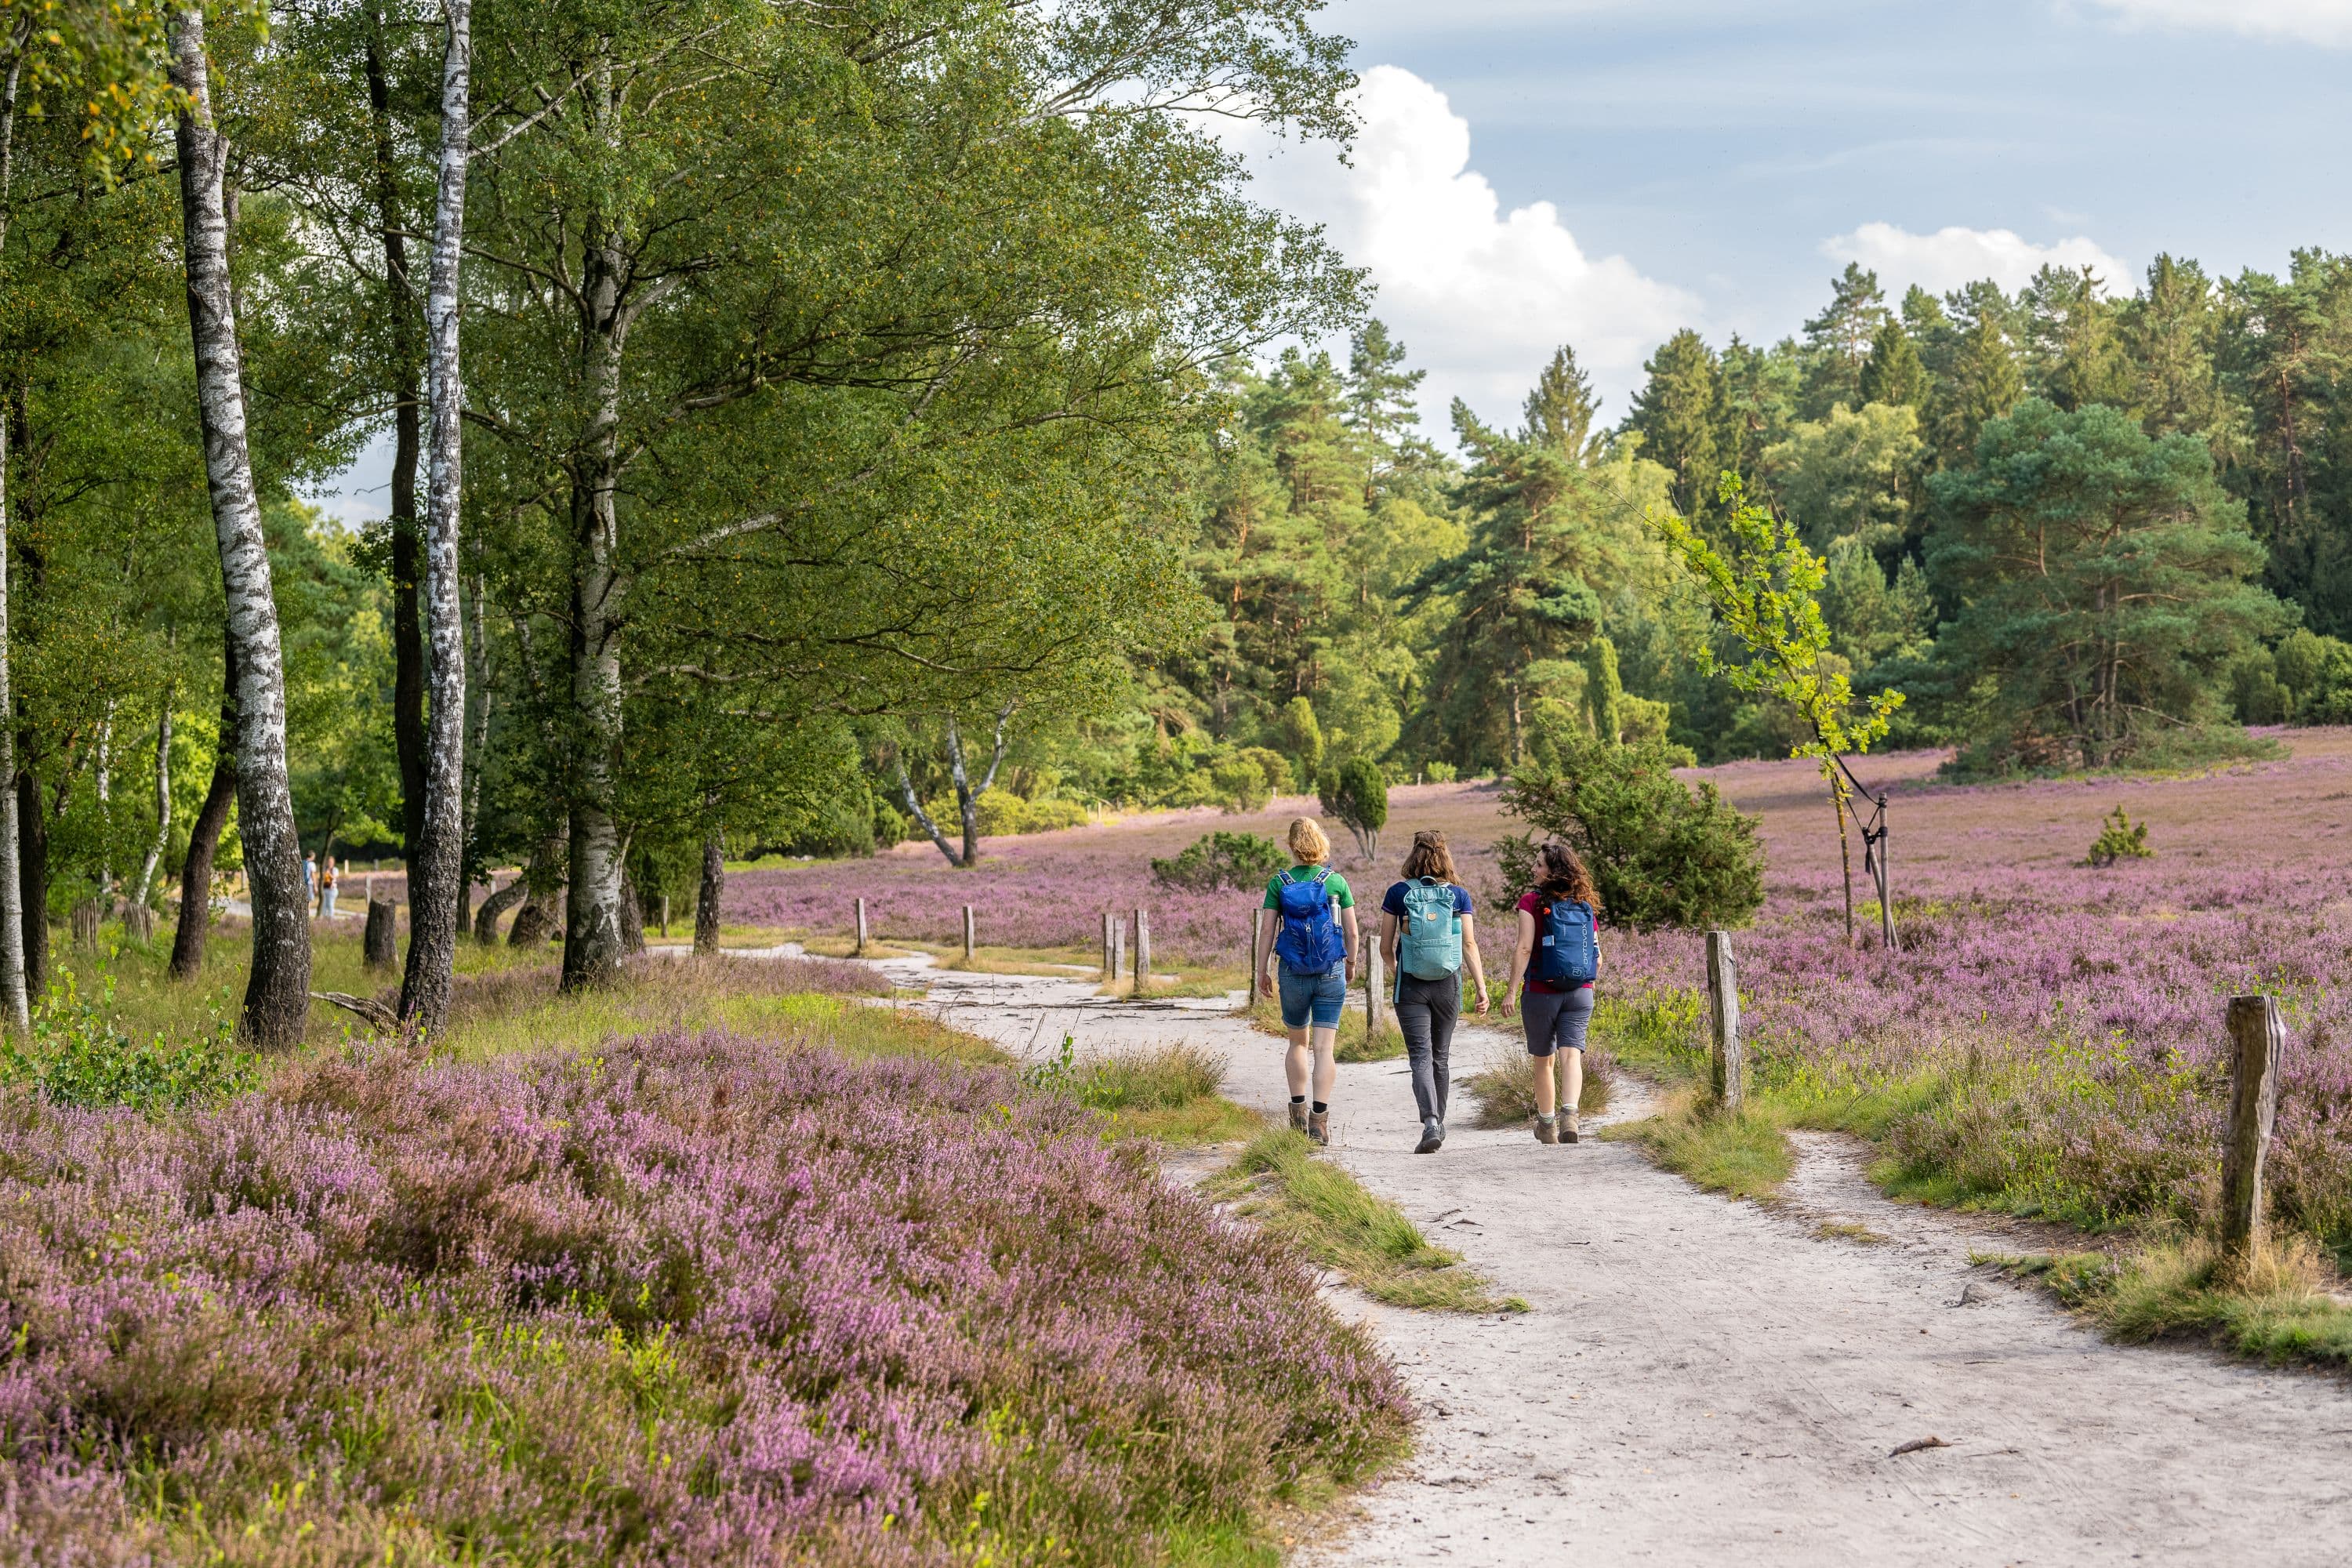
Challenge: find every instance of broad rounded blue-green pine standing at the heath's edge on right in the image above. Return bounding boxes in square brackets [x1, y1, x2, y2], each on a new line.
[1926, 400, 2288, 769]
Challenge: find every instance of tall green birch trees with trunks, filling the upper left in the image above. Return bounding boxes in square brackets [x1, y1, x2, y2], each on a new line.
[0, 0, 1362, 1044]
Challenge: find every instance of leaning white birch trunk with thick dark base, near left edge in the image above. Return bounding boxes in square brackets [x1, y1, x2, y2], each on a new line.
[169, 5, 310, 1046]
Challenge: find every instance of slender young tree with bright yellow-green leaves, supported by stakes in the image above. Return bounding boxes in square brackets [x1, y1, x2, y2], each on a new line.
[1651, 475, 1903, 945]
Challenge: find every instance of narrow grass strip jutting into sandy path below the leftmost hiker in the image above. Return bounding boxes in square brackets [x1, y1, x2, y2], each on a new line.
[1207, 1128, 1526, 1312]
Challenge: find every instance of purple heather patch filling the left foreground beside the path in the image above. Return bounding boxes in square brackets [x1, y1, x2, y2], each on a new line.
[0, 1032, 1406, 1568]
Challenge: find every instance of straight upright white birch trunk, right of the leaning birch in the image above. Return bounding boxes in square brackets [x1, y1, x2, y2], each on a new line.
[400, 0, 473, 1032]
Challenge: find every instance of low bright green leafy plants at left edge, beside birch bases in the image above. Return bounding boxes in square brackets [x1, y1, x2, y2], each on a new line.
[0, 959, 263, 1114]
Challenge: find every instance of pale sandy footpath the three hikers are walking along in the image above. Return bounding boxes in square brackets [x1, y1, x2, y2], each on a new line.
[790, 949, 2352, 1568]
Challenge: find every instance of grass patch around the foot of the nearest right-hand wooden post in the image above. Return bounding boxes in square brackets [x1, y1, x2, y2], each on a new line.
[1976, 1236, 2352, 1368]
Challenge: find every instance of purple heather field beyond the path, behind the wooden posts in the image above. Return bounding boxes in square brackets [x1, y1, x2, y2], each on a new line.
[729, 729, 2352, 1253]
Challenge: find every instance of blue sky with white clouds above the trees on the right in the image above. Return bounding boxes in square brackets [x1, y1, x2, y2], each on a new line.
[322, 0, 2352, 520]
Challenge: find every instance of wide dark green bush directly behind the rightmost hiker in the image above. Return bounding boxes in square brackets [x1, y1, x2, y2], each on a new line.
[1494, 734, 1764, 931]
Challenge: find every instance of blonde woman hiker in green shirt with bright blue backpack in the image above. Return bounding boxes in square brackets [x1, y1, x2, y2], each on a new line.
[1258, 815, 1357, 1142]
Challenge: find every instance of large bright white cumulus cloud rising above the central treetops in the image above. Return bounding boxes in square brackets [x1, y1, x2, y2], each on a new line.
[1249, 66, 1698, 440]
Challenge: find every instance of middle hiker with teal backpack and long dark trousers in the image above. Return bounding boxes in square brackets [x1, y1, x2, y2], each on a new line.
[1381, 832, 1486, 1154]
